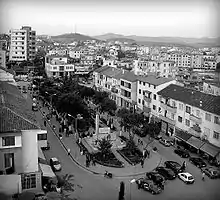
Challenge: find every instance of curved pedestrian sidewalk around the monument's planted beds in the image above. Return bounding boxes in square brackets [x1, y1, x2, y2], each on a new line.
[37, 102, 161, 177]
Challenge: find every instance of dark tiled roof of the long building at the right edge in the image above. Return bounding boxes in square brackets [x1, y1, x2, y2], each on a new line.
[158, 84, 220, 115]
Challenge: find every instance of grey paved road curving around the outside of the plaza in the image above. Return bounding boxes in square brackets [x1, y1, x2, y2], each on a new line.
[16, 80, 220, 200]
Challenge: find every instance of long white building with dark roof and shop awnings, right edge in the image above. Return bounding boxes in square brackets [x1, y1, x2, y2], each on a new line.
[158, 84, 220, 160]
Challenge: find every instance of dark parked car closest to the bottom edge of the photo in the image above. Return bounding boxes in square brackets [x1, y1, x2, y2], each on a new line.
[136, 178, 162, 194]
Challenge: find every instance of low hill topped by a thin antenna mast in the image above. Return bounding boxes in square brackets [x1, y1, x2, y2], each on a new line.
[51, 33, 97, 43]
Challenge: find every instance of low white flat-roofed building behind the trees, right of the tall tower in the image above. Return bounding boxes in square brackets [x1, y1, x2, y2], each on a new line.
[45, 55, 75, 77]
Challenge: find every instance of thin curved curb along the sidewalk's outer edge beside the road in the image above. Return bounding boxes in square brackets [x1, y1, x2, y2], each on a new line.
[39, 106, 162, 178]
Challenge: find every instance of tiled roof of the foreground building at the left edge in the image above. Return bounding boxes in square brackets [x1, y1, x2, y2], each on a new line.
[0, 82, 40, 133]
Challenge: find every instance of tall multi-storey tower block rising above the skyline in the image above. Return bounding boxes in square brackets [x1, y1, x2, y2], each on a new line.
[9, 26, 36, 61]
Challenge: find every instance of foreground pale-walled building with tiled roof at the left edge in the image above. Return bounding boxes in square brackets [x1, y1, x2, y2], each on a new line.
[0, 82, 42, 194]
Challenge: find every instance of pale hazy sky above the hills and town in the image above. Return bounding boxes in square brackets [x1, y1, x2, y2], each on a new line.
[0, 0, 220, 37]
